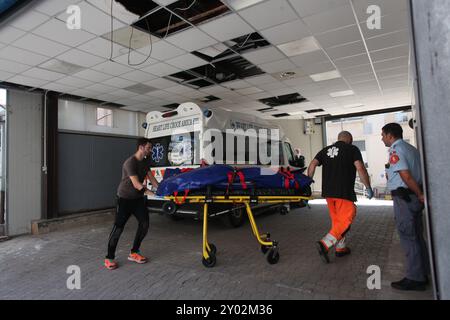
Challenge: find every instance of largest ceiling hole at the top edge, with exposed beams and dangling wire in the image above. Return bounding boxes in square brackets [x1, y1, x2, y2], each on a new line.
[130, 0, 231, 38]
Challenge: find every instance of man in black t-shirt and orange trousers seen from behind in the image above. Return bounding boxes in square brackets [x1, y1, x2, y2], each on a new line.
[308, 131, 373, 263]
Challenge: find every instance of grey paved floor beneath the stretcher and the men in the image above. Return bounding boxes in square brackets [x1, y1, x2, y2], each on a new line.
[0, 204, 432, 300]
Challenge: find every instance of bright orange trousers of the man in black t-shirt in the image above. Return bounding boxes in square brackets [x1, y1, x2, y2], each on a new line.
[326, 198, 356, 241]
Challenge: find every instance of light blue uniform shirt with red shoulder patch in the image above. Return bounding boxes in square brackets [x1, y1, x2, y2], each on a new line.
[386, 139, 422, 191]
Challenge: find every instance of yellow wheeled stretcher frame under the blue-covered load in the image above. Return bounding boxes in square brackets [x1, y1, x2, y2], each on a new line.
[164, 195, 312, 268]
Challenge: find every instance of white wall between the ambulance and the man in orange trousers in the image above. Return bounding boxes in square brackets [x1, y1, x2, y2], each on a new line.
[272, 120, 324, 192]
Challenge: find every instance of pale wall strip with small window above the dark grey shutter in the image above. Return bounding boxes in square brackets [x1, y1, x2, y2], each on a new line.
[58, 100, 145, 136]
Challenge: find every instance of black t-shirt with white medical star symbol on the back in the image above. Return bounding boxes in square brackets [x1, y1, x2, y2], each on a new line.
[315, 141, 363, 202]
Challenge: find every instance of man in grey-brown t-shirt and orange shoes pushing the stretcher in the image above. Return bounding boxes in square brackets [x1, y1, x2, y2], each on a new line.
[105, 138, 158, 270]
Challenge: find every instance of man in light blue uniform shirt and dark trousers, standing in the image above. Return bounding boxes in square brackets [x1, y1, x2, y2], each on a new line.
[381, 123, 429, 291]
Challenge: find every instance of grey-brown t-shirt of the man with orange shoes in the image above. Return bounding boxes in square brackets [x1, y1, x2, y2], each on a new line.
[117, 155, 148, 199]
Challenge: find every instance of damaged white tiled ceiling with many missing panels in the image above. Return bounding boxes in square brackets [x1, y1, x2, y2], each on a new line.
[0, 0, 413, 119]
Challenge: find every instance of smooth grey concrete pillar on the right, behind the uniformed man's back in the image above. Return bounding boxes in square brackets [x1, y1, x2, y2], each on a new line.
[411, 0, 450, 299]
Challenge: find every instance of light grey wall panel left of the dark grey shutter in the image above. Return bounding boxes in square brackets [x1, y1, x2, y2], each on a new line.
[6, 90, 43, 236]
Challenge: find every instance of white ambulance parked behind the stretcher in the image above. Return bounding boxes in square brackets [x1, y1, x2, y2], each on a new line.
[143, 102, 304, 227]
